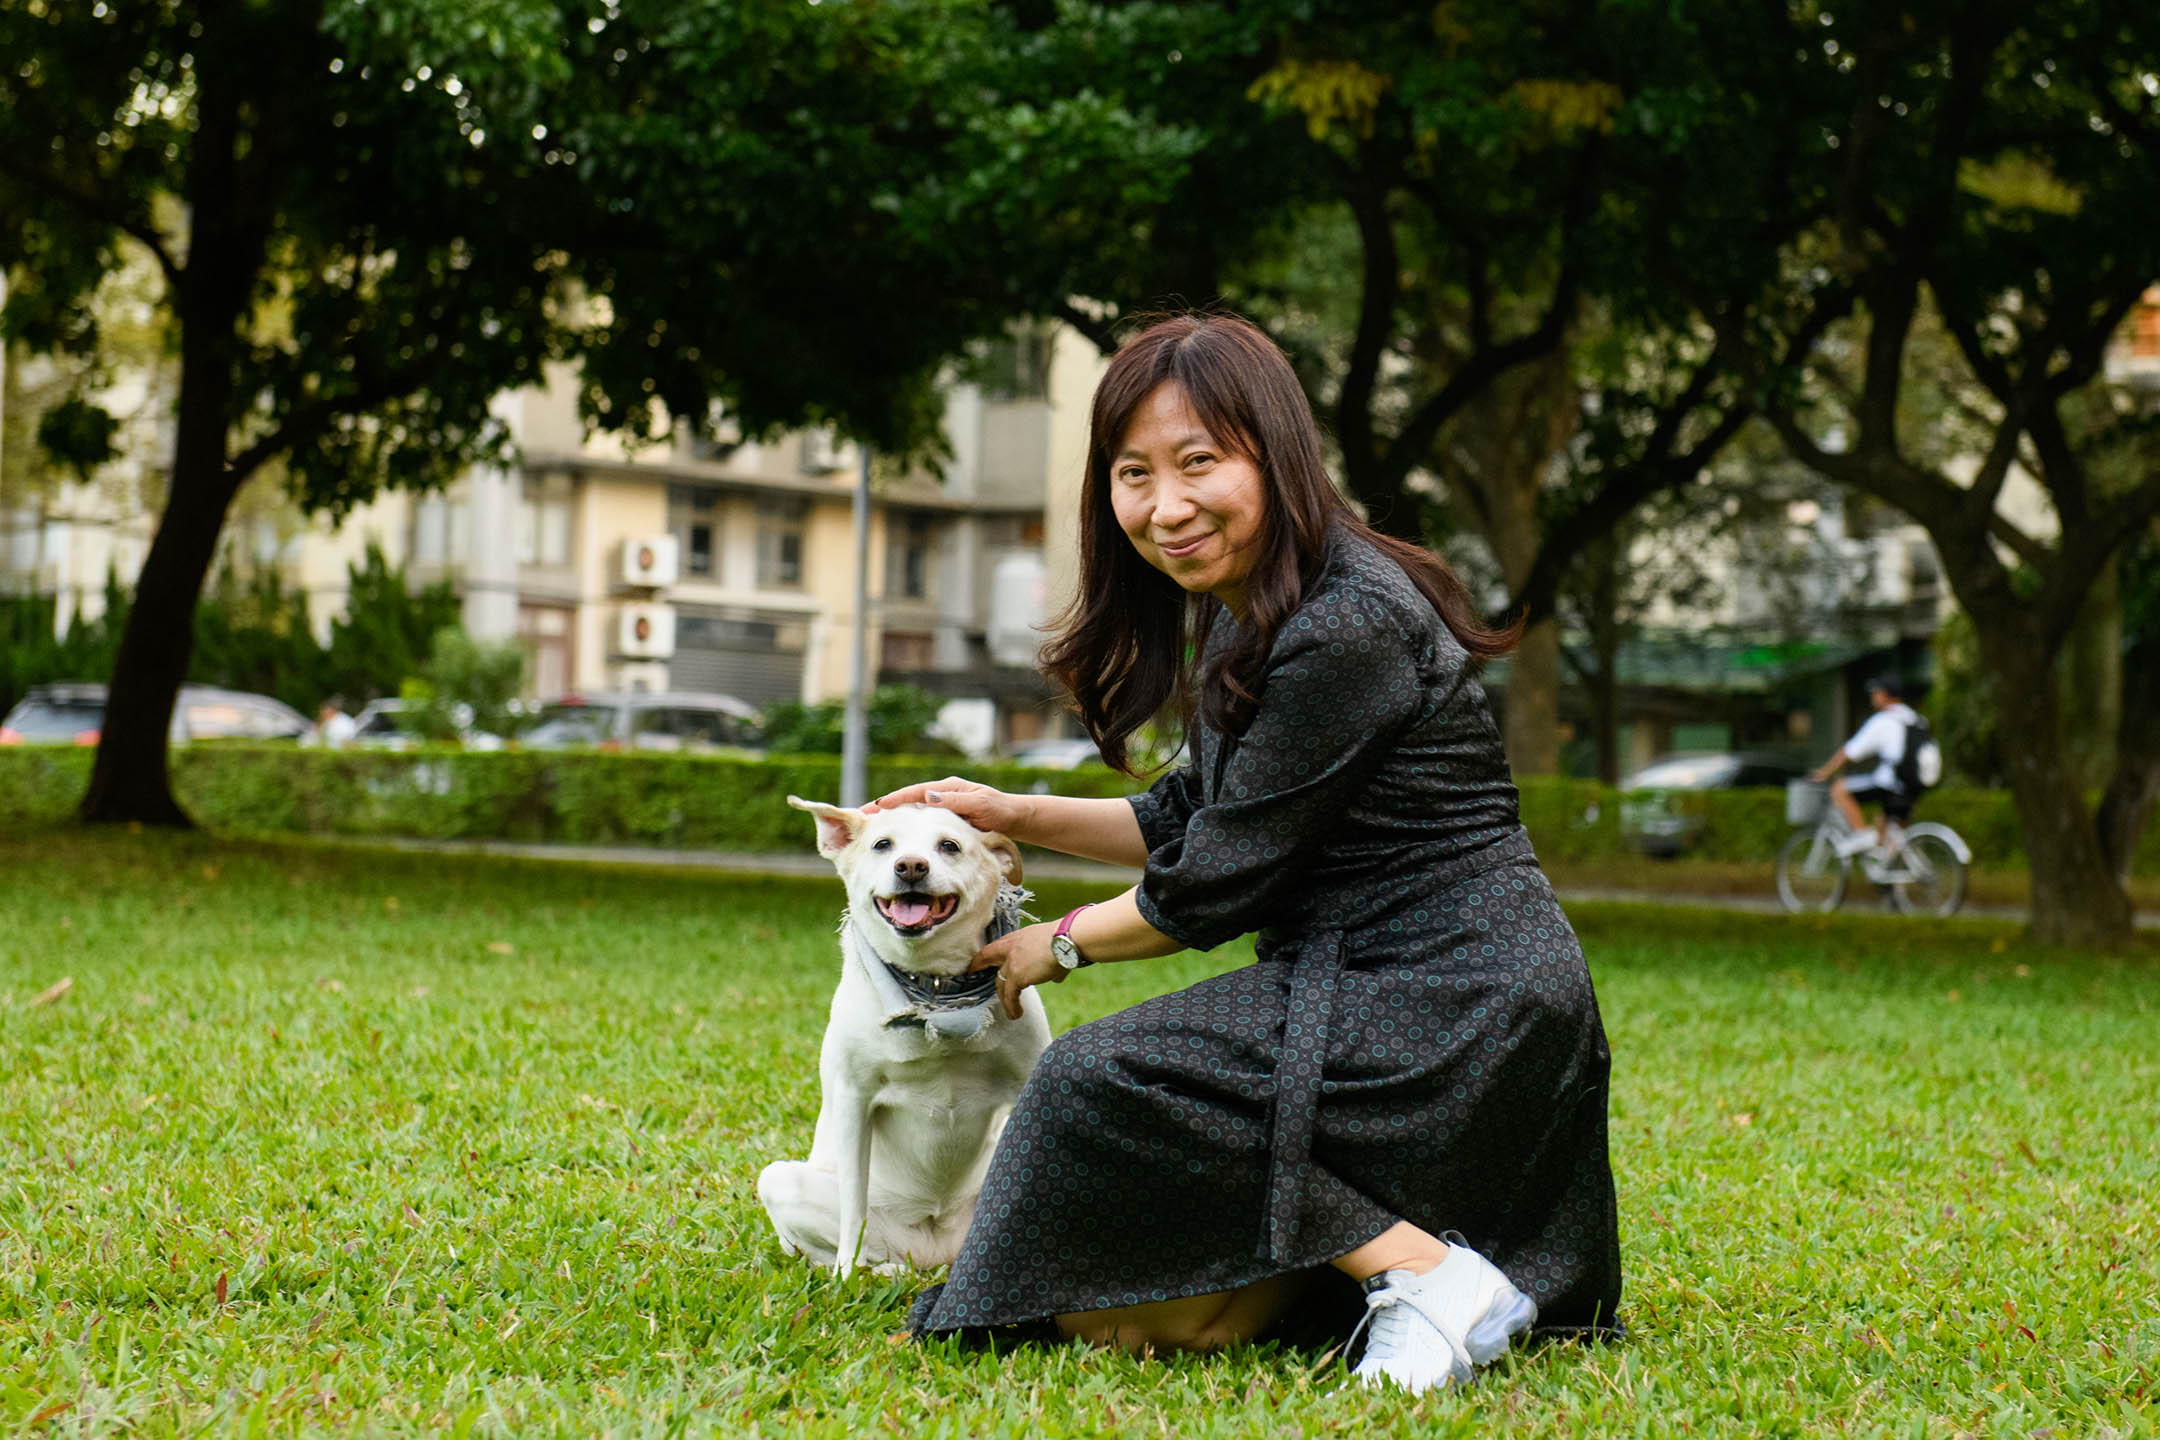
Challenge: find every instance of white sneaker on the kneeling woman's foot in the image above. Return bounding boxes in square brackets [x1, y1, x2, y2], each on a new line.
[1350, 1241, 1538, 1395]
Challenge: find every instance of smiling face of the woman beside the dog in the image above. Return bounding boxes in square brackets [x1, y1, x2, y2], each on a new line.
[1110, 380, 1268, 615]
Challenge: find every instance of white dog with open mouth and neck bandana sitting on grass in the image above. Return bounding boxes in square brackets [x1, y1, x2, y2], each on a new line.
[758, 794, 1050, 1276]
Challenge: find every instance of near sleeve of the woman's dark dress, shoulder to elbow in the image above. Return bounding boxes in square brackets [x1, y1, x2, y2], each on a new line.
[1134, 596, 1423, 950]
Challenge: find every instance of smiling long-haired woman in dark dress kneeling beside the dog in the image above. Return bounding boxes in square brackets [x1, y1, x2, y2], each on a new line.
[877, 315, 1620, 1390]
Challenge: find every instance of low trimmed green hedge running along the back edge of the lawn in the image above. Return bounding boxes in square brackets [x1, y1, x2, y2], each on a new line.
[0, 745, 2160, 874]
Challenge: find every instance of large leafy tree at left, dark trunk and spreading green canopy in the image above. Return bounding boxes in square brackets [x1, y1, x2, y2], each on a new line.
[0, 0, 1184, 823]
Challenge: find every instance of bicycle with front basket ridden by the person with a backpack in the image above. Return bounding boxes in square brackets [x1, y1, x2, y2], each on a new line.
[1778, 779, 1972, 915]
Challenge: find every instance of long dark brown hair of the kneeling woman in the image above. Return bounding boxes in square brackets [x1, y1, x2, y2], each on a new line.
[1043, 313, 1521, 773]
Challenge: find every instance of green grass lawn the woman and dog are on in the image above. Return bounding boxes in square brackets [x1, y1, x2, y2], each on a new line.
[0, 827, 2160, 1438]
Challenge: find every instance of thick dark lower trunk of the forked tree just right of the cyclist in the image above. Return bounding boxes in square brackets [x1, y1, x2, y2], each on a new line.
[1979, 630, 2132, 948]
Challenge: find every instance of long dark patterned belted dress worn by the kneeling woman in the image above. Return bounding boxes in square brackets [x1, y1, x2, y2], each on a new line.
[916, 531, 1620, 1334]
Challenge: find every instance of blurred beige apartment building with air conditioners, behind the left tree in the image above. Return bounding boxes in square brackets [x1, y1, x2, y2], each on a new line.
[0, 328, 1102, 749]
